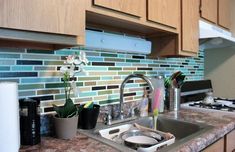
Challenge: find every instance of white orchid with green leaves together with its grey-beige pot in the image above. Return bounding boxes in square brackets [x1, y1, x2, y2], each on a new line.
[53, 51, 88, 139]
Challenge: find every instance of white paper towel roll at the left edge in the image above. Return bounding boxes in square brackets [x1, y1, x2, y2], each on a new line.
[0, 82, 20, 152]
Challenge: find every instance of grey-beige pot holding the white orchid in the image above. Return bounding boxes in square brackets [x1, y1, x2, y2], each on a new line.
[54, 116, 78, 139]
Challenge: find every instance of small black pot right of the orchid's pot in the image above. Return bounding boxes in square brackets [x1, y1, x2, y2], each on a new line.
[78, 105, 100, 129]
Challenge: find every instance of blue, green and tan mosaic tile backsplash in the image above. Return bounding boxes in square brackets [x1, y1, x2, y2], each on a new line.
[0, 48, 204, 114]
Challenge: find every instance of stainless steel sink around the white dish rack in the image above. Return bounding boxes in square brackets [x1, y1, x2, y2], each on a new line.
[80, 116, 212, 152]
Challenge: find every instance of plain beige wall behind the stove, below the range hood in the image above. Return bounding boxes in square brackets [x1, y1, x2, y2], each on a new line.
[205, 47, 235, 98]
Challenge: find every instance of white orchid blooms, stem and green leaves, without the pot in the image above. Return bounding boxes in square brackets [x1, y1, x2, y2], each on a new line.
[53, 51, 88, 118]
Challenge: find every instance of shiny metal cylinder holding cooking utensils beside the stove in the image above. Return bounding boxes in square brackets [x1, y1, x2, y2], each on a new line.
[169, 88, 181, 111]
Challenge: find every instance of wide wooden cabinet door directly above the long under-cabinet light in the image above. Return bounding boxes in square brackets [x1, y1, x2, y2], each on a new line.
[93, 0, 144, 17]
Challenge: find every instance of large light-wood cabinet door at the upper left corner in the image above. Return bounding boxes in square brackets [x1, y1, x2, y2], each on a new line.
[0, 0, 85, 35]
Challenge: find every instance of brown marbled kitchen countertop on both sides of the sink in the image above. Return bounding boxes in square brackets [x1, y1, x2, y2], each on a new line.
[20, 106, 235, 152]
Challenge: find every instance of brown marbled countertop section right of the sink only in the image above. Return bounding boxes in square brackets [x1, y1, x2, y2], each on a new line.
[164, 106, 235, 152]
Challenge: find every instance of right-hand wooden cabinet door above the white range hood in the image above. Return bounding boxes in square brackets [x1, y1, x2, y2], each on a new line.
[218, 0, 231, 29]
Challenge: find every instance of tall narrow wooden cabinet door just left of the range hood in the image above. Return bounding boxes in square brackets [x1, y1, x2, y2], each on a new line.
[181, 0, 199, 55]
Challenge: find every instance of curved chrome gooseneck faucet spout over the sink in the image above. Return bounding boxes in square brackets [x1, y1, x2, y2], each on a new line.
[119, 74, 154, 120]
